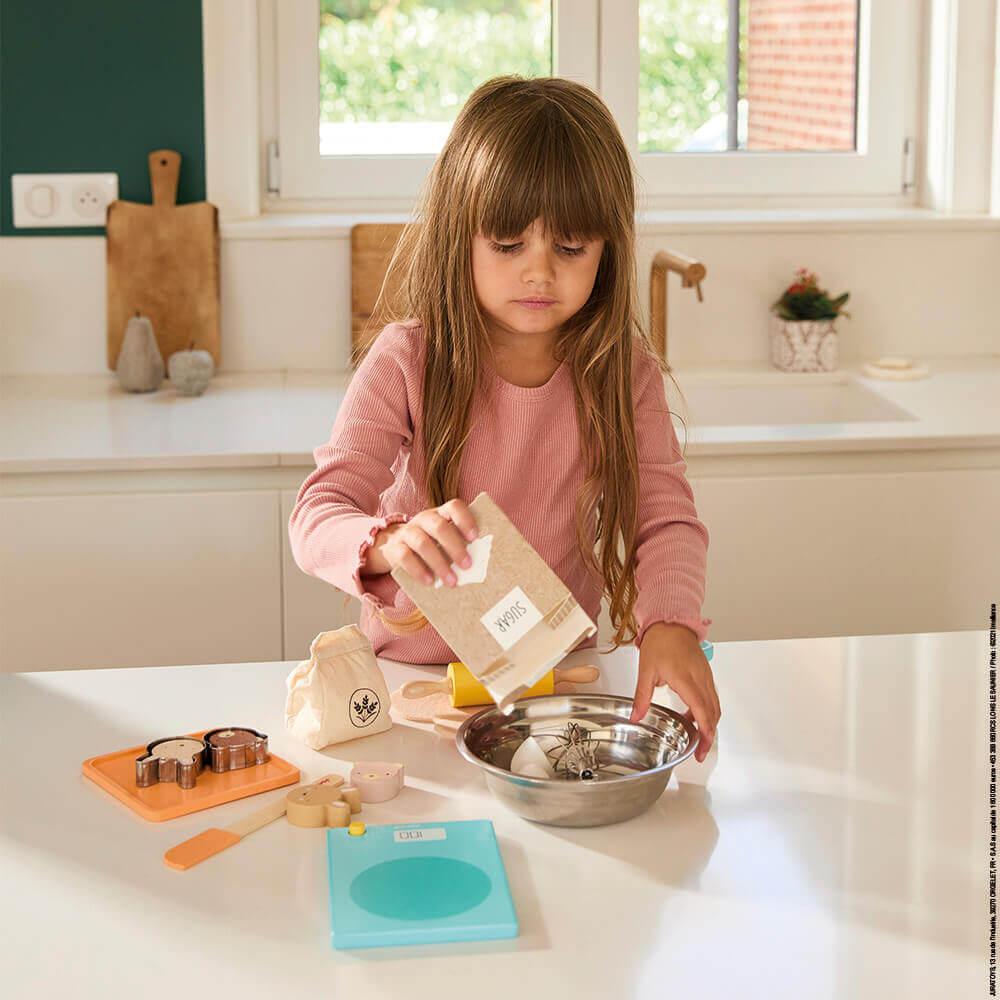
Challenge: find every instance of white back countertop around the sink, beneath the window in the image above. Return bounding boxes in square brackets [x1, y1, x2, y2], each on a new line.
[0, 355, 1000, 474]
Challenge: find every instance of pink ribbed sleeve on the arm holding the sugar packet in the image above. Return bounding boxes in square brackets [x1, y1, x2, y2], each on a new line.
[288, 324, 413, 608]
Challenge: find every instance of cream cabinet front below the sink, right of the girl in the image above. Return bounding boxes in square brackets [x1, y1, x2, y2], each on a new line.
[691, 463, 1000, 640]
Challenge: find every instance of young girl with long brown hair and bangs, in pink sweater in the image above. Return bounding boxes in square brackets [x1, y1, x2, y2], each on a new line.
[289, 76, 720, 760]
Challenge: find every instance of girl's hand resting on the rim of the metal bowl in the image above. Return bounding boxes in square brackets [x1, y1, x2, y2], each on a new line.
[629, 622, 722, 762]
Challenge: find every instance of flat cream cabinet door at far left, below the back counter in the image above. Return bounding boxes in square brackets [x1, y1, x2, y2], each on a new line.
[0, 490, 282, 672]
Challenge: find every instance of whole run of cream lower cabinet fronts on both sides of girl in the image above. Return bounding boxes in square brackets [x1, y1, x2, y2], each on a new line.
[0, 466, 1000, 671]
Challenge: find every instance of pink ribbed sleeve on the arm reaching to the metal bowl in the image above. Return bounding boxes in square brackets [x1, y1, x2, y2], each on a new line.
[634, 358, 712, 646]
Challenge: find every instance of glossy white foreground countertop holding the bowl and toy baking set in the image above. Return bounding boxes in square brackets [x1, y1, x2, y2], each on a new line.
[0, 631, 988, 1000]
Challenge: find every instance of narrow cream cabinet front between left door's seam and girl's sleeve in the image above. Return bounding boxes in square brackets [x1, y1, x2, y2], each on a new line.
[280, 490, 361, 660]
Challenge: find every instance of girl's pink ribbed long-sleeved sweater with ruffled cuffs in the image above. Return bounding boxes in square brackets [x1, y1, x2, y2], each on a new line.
[288, 320, 711, 663]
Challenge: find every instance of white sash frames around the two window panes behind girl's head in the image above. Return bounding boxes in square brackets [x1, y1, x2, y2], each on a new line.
[275, 0, 919, 210]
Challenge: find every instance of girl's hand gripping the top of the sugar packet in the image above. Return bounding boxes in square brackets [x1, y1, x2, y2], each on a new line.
[367, 497, 479, 587]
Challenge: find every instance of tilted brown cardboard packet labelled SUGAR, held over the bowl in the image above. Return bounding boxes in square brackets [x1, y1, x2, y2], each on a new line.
[392, 493, 597, 713]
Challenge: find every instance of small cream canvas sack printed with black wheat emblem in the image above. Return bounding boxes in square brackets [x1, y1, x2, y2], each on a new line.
[285, 625, 392, 750]
